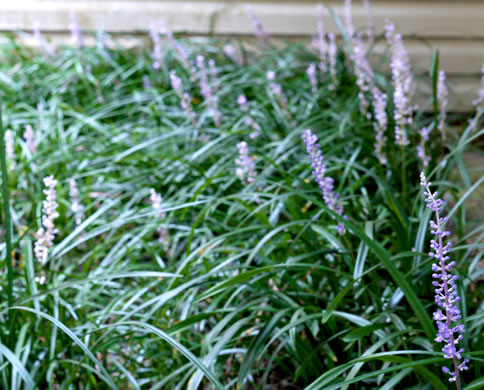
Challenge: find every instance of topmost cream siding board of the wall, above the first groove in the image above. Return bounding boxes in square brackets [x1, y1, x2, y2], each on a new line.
[0, 0, 484, 39]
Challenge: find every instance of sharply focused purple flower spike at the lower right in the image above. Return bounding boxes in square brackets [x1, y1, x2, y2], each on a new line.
[420, 172, 469, 389]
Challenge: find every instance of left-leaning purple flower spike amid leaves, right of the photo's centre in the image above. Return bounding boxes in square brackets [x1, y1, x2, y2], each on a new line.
[302, 130, 347, 235]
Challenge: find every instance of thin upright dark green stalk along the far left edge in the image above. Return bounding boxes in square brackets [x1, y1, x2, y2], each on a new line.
[0, 104, 14, 310]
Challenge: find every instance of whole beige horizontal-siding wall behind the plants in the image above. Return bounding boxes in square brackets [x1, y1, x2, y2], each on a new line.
[0, 0, 484, 111]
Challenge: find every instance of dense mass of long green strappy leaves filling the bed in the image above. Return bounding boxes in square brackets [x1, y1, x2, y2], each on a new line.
[0, 5, 484, 389]
